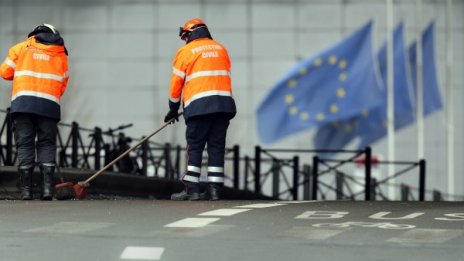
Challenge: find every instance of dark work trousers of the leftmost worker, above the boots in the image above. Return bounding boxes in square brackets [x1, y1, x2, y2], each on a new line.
[13, 113, 58, 169]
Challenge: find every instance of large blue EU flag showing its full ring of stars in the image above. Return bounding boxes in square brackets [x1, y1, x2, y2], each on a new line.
[257, 22, 383, 143]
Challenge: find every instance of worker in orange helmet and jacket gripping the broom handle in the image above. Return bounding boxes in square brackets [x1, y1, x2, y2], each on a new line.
[164, 18, 237, 200]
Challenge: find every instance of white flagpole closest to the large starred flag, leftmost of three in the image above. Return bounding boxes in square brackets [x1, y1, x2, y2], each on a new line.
[387, 0, 396, 200]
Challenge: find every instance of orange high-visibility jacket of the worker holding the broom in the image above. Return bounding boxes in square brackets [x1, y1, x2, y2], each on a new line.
[169, 38, 236, 120]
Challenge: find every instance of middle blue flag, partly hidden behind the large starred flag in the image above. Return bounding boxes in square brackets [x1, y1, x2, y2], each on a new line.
[314, 23, 415, 149]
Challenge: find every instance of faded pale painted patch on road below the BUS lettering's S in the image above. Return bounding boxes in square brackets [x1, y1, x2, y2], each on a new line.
[387, 229, 464, 244]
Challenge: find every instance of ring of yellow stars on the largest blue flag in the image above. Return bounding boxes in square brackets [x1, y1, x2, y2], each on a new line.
[285, 55, 348, 121]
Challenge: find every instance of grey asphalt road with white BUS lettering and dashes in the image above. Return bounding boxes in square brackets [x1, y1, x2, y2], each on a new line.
[0, 199, 464, 261]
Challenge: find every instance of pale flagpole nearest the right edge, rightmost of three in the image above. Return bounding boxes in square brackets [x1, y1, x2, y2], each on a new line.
[446, 0, 455, 200]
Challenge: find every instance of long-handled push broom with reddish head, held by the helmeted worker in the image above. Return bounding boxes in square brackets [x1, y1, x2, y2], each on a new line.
[55, 112, 182, 199]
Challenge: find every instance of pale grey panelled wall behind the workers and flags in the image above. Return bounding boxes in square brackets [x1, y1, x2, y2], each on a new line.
[0, 0, 464, 197]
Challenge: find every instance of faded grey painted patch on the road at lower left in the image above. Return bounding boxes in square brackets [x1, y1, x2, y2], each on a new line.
[23, 222, 114, 234]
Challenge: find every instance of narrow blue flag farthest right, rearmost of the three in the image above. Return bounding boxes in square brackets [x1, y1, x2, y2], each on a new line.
[409, 22, 443, 115]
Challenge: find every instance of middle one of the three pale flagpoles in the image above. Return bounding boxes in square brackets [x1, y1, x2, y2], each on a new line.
[416, 0, 425, 160]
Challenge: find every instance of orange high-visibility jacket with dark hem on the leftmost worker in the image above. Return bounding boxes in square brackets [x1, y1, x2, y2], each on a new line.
[0, 36, 69, 120]
